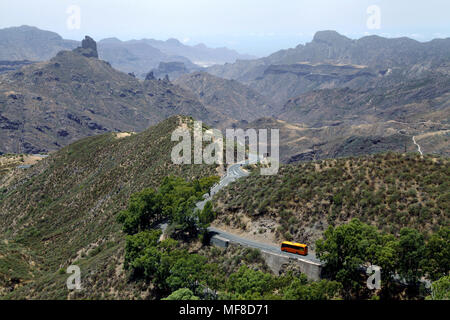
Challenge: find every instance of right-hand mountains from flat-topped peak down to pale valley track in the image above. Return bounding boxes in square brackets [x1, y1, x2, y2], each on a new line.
[206, 31, 450, 162]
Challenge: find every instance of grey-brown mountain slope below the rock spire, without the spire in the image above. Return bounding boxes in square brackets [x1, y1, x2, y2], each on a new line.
[0, 39, 208, 153]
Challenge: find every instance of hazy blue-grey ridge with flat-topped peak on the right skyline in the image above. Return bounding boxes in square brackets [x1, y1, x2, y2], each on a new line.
[208, 31, 450, 82]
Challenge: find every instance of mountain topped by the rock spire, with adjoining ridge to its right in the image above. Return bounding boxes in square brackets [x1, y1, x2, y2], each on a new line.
[0, 37, 272, 153]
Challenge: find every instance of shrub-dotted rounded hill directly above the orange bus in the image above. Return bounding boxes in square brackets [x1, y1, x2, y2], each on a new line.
[214, 153, 450, 249]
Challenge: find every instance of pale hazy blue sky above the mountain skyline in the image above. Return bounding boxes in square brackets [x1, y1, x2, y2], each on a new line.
[0, 0, 450, 56]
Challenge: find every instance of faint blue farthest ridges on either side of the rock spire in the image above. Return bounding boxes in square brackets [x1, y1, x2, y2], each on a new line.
[0, 26, 254, 78]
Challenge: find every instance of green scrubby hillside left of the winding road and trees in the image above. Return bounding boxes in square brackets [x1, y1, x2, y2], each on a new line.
[0, 117, 217, 299]
